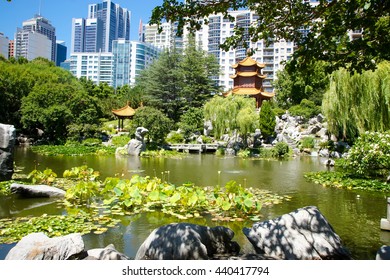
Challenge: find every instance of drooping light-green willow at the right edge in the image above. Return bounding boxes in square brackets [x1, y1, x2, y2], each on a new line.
[322, 62, 390, 140]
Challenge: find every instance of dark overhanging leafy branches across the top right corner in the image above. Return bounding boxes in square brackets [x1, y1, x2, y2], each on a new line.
[150, 0, 390, 72]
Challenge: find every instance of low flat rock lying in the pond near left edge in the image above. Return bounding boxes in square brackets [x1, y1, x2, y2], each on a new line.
[10, 183, 65, 198]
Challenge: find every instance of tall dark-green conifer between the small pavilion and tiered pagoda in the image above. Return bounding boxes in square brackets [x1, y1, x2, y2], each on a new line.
[137, 36, 219, 122]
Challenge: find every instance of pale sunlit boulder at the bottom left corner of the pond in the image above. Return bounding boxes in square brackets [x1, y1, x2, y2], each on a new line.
[5, 232, 85, 260]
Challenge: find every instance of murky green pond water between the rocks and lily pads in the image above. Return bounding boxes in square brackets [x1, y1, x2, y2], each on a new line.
[0, 148, 390, 260]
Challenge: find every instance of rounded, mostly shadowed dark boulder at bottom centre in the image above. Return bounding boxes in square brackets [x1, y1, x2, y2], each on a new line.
[135, 223, 240, 260]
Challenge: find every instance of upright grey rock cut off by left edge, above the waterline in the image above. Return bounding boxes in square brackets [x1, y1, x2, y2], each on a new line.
[0, 124, 16, 181]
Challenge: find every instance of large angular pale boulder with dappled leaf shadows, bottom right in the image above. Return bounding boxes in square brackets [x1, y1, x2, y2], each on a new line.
[243, 206, 351, 260]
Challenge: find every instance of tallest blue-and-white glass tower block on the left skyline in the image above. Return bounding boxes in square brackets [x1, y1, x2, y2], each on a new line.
[71, 0, 131, 53]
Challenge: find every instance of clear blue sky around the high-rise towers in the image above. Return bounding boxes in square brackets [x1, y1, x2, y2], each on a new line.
[0, 0, 163, 53]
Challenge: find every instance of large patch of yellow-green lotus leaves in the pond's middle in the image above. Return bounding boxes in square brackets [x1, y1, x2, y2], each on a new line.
[100, 175, 286, 220]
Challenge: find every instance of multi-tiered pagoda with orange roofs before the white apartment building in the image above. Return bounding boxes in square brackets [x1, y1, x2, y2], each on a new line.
[224, 56, 275, 108]
